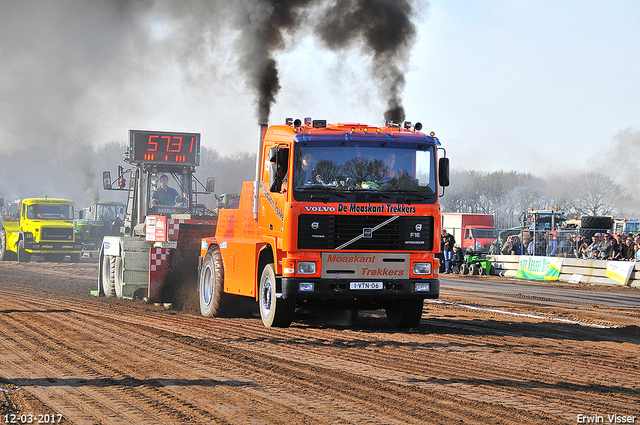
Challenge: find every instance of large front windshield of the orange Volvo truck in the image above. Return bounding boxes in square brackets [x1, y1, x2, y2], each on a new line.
[293, 141, 437, 196]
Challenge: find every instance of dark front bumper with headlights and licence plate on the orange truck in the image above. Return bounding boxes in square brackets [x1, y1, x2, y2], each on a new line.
[282, 277, 440, 302]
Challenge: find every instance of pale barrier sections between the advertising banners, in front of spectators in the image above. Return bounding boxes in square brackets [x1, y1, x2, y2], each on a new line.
[487, 255, 640, 289]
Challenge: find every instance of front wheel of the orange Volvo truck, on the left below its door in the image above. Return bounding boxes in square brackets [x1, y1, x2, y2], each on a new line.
[258, 263, 296, 328]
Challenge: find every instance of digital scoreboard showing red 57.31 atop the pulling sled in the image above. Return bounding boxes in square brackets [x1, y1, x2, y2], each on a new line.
[129, 130, 200, 166]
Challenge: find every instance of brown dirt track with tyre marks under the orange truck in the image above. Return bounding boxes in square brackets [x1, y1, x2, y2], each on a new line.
[0, 262, 640, 424]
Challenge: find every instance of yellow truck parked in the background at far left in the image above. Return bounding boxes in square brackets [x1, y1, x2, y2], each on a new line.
[0, 198, 82, 263]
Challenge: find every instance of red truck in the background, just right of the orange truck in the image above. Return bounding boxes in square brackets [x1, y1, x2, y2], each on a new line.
[442, 213, 498, 252]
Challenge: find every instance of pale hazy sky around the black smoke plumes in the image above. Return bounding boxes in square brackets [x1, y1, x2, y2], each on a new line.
[0, 0, 640, 176]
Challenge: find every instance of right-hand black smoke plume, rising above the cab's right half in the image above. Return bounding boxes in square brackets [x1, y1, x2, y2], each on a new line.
[315, 0, 427, 123]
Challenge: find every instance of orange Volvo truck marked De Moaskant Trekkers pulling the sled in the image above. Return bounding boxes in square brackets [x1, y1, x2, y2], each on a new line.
[198, 118, 449, 328]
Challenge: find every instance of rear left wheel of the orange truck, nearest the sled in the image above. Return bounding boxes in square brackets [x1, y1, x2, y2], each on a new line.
[198, 246, 232, 317]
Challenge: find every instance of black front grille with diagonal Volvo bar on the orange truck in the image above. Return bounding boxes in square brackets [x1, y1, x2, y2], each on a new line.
[298, 214, 433, 251]
